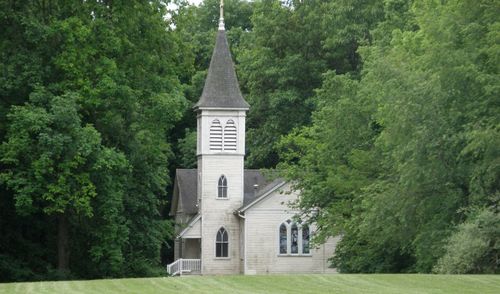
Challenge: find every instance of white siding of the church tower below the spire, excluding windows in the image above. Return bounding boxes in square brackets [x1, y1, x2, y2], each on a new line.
[197, 110, 245, 275]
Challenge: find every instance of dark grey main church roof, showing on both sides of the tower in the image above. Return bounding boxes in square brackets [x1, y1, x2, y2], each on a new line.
[170, 169, 283, 215]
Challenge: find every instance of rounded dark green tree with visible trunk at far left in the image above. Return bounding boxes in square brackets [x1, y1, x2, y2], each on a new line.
[1, 89, 127, 270]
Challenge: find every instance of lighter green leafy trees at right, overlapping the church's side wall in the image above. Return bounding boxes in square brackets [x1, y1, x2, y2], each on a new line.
[280, 0, 500, 273]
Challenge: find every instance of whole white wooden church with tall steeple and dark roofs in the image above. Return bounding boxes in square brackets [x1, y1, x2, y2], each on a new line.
[167, 5, 337, 275]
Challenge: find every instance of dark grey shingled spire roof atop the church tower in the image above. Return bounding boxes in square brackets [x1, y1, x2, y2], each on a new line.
[194, 30, 249, 109]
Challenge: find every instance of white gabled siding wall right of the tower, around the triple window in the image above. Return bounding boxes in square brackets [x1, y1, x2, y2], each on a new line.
[245, 185, 338, 274]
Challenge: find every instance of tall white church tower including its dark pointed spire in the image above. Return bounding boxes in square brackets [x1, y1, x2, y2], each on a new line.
[194, 1, 249, 274]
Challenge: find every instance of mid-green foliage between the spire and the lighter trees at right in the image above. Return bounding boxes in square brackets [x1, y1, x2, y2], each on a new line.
[237, 0, 383, 168]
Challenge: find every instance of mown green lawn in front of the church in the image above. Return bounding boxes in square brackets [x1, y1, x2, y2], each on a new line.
[0, 274, 500, 294]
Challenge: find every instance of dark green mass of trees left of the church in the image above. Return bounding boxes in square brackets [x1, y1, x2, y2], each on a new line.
[0, 0, 185, 280]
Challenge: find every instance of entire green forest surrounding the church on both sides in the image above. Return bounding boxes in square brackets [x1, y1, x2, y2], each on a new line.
[0, 0, 500, 281]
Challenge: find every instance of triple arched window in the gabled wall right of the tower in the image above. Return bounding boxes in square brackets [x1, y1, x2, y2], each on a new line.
[278, 220, 311, 255]
